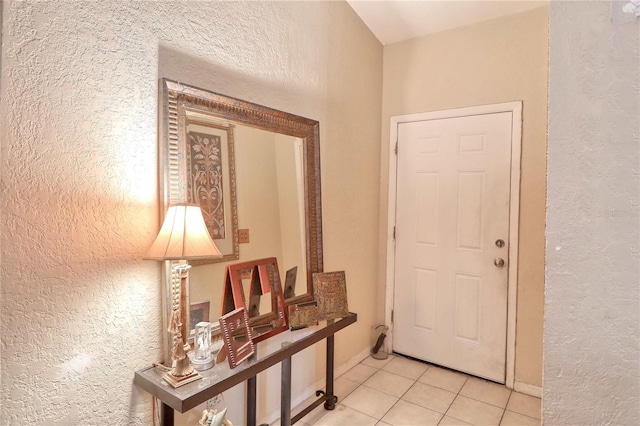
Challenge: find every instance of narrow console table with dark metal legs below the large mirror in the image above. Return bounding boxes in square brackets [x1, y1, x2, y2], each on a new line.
[133, 313, 358, 426]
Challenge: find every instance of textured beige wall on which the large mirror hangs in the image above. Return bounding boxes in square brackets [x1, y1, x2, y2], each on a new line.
[0, 0, 382, 425]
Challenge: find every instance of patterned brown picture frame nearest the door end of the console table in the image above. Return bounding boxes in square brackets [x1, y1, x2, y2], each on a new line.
[312, 271, 349, 320]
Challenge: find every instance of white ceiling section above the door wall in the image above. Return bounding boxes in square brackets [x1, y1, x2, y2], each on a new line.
[347, 0, 549, 45]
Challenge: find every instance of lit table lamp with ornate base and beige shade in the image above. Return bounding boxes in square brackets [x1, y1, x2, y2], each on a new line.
[144, 204, 222, 387]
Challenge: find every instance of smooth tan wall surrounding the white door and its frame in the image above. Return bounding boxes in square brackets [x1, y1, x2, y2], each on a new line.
[378, 7, 548, 386]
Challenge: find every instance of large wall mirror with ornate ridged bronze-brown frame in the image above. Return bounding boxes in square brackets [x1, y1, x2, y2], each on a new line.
[160, 79, 322, 342]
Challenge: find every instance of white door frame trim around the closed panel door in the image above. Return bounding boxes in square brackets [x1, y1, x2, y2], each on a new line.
[385, 101, 522, 389]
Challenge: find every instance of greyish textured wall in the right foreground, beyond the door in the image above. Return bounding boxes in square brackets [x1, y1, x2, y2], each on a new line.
[542, 1, 640, 425]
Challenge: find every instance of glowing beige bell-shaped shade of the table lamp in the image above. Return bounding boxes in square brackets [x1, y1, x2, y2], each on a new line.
[144, 204, 222, 260]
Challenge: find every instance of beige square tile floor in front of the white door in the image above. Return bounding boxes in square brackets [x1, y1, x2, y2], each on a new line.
[290, 355, 540, 426]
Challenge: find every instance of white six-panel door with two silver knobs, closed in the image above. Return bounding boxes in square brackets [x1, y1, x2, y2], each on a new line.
[393, 112, 512, 383]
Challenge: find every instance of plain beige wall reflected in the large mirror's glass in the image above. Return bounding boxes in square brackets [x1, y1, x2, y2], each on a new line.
[189, 126, 307, 328]
